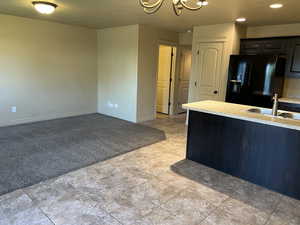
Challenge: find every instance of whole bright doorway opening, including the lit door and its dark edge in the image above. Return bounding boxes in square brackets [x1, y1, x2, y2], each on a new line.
[156, 45, 177, 115]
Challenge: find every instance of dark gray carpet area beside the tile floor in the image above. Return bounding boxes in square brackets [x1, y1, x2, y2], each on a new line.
[0, 114, 165, 195]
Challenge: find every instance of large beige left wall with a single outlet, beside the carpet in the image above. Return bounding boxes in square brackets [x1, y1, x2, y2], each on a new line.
[0, 15, 97, 126]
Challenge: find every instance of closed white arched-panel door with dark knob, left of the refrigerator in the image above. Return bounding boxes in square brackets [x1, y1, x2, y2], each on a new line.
[194, 42, 224, 101]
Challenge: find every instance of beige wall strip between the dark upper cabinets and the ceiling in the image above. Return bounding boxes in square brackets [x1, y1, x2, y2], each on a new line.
[247, 23, 300, 38]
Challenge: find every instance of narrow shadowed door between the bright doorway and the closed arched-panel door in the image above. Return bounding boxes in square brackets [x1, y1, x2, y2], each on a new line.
[177, 47, 192, 113]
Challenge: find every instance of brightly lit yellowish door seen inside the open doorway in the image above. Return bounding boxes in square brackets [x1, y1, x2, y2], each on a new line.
[156, 45, 172, 114]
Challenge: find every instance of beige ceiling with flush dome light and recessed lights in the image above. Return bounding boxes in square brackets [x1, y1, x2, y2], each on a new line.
[0, 0, 300, 32]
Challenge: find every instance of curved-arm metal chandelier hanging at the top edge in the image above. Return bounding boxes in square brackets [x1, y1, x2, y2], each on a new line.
[139, 0, 208, 16]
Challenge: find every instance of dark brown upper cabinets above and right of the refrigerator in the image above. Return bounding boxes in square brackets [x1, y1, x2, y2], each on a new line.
[240, 37, 300, 78]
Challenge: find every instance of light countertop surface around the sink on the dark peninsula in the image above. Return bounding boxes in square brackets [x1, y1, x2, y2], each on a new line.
[182, 101, 300, 131]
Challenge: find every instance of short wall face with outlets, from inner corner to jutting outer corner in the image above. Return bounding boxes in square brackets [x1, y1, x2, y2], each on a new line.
[98, 25, 139, 122]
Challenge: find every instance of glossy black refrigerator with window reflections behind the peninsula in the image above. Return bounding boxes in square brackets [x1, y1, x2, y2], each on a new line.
[226, 55, 286, 108]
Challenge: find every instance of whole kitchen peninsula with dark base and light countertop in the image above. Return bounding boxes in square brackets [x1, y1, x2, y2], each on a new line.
[183, 101, 300, 199]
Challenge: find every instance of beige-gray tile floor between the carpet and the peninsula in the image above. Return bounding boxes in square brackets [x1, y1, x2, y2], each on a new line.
[0, 115, 300, 225]
